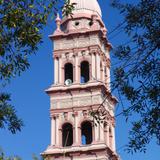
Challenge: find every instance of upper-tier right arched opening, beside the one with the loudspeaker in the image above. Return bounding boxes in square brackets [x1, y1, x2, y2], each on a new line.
[80, 61, 89, 83]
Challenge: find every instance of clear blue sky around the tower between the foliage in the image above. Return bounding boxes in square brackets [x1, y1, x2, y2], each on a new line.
[0, 0, 160, 160]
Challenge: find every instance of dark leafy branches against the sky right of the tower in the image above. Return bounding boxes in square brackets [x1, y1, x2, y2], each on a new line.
[112, 0, 160, 153]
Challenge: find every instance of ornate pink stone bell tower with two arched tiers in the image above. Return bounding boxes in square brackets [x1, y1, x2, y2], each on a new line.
[42, 0, 119, 160]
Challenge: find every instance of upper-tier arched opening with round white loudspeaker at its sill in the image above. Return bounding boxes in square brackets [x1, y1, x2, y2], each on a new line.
[64, 63, 73, 82]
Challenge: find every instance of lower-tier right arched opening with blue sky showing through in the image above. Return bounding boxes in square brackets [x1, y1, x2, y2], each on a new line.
[81, 121, 92, 145]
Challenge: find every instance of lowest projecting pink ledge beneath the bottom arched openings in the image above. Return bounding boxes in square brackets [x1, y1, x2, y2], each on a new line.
[41, 144, 120, 160]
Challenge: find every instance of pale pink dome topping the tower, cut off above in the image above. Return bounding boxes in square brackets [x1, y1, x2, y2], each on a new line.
[70, 0, 102, 17]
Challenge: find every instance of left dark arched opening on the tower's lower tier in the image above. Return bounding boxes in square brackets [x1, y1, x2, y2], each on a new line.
[62, 123, 73, 147]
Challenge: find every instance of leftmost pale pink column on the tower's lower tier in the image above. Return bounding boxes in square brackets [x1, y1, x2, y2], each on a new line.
[51, 117, 56, 146]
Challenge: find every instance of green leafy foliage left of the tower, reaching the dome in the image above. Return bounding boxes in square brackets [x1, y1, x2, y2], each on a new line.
[0, 0, 74, 133]
